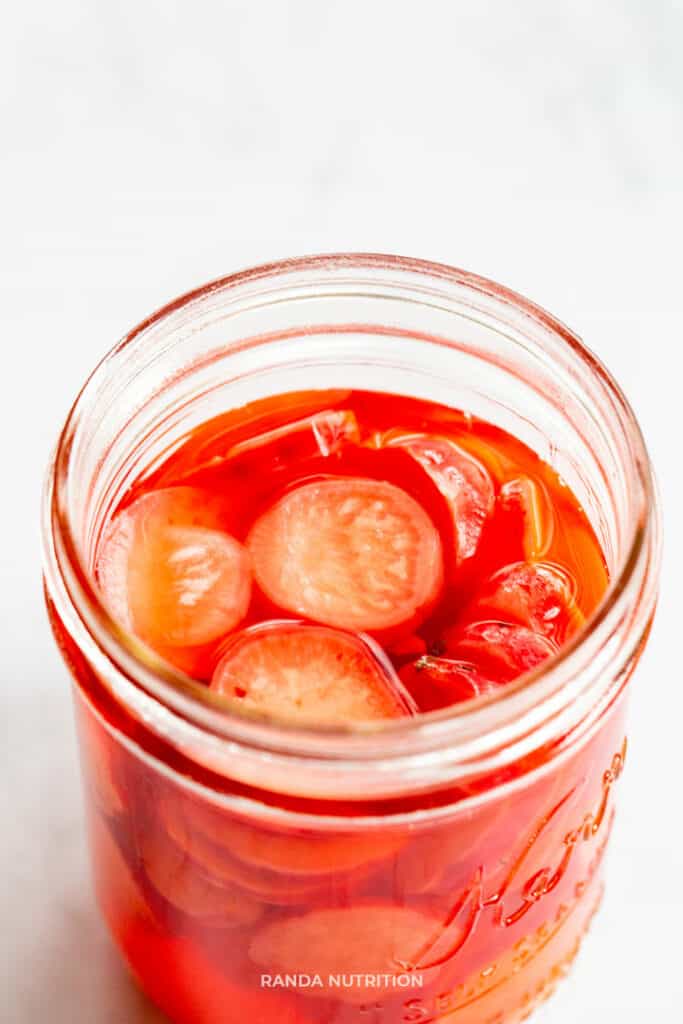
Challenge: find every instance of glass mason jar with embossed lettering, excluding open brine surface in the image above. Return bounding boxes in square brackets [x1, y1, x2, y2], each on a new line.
[44, 249, 659, 1024]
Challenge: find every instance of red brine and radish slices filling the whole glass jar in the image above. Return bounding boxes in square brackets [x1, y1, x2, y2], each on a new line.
[41, 256, 651, 1024]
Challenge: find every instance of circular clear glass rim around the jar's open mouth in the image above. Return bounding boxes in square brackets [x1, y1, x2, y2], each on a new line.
[43, 253, 659, 761]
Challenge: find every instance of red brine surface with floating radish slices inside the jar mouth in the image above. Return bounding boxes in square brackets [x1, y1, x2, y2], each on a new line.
[95, 391, 607, 700]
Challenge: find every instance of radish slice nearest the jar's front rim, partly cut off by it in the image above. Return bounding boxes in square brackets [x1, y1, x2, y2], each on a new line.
[211, 623, 415, 725]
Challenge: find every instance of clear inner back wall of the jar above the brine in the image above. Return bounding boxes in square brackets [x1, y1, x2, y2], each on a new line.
[67, 272, 636, 574]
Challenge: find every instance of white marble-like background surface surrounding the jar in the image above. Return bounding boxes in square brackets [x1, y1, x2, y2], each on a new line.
[0, 0, 683, 1024]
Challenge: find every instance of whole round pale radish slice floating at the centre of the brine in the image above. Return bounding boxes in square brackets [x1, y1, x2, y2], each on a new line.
[247, 477, 443, 631]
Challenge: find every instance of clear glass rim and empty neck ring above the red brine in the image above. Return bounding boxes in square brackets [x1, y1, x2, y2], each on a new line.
[46, 256, 657, 795]
